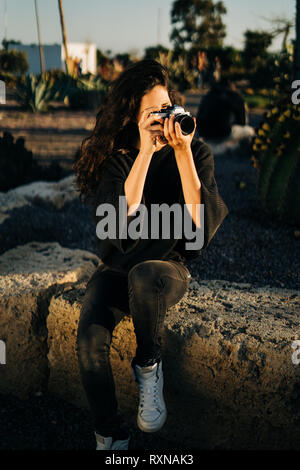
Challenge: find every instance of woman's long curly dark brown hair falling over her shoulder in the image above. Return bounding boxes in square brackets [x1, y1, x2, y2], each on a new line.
[72, 59, 181, 206]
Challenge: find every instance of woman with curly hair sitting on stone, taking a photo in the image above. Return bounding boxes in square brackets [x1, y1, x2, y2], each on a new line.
[74, 60, 228, 450]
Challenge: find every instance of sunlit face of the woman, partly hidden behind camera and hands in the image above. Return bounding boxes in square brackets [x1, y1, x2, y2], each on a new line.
[137, 85, 172, 147]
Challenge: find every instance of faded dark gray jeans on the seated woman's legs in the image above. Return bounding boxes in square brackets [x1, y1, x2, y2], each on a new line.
[77, 260, 191, 436]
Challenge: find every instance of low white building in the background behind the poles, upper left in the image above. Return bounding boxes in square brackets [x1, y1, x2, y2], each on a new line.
[8, 42, 97, 75]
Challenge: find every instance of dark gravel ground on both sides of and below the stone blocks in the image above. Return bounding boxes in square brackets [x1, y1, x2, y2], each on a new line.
[0, 111, 300, 450]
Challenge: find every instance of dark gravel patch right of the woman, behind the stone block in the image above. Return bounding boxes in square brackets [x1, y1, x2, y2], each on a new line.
[191, 148, 300, 289]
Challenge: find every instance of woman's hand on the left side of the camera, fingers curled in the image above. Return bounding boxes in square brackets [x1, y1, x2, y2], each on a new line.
[138, 110, 165, 156]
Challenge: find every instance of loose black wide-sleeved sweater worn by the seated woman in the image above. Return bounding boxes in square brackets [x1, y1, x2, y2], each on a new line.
[95, 139, 228, 273]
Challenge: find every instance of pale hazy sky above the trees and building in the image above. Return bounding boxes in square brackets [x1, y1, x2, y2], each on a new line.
[0, 0, 296, 56]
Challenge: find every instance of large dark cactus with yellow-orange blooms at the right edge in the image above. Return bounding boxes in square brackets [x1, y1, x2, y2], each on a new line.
[251, 52, 300, 226]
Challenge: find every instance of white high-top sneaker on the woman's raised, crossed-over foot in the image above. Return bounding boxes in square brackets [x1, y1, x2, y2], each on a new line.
[132, 361, 167, 432]
